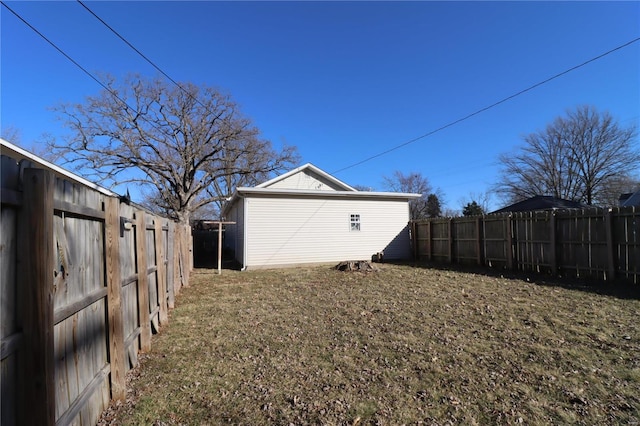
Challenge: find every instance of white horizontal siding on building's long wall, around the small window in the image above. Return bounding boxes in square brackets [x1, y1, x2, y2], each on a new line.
[245, 197, 410, 267]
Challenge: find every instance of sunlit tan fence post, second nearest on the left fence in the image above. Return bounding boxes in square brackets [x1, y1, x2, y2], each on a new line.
[105, 197, 125, 401]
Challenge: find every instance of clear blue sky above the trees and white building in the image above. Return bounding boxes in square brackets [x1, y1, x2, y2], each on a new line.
[0, 1, 640, 209]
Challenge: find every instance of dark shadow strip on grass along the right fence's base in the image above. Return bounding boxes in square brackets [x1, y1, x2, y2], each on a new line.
[385, 261, 640, 300]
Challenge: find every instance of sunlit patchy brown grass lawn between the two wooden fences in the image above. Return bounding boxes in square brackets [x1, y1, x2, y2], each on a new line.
[101, 264, 640, 425]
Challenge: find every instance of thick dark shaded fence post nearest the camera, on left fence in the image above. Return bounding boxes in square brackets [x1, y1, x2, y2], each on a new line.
[16, 169, 55, 425]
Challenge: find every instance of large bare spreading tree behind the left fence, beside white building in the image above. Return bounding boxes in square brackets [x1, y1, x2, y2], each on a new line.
[49, 75, 298, 223]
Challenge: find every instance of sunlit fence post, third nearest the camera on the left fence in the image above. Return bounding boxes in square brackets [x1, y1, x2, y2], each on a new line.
[136, 211, 151, 352]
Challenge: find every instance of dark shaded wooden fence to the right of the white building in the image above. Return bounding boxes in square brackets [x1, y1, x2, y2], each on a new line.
[411, 207, 640, 284]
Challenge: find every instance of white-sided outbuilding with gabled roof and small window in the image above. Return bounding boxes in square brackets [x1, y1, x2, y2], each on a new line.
[223, 164, 420, 268]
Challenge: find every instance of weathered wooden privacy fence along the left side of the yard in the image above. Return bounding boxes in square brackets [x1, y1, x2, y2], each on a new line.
[0, 145, 192, 425]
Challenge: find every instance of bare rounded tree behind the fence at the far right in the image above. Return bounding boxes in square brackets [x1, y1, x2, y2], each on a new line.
[495, 106, 640, 205]
